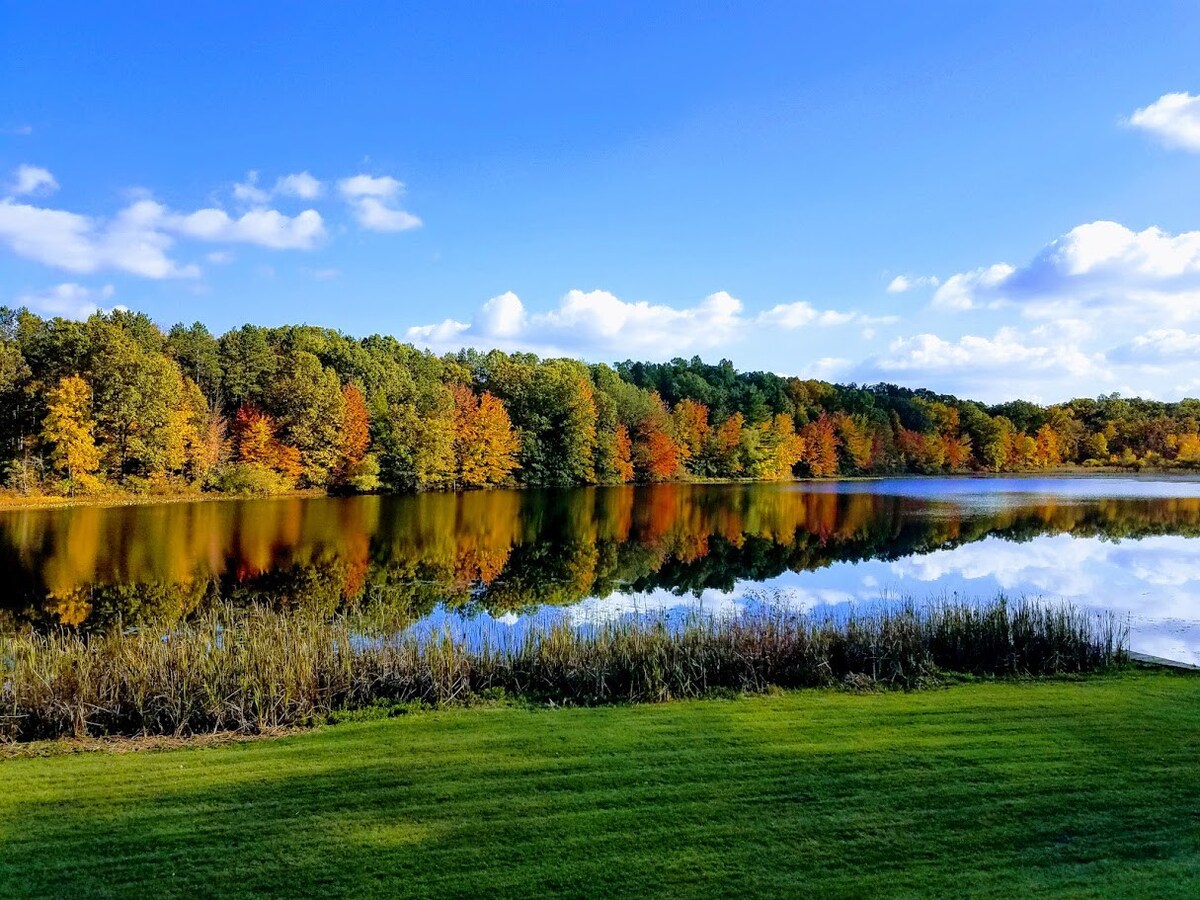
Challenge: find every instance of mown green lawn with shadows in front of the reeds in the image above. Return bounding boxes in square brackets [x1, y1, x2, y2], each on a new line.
[0, 672, 1200, 898]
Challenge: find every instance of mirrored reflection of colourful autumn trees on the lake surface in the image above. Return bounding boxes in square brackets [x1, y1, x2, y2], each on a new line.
[7, 481, 1200, 628]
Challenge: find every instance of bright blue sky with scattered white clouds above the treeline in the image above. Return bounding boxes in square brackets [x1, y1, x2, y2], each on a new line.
[0, 2, 1200, 401]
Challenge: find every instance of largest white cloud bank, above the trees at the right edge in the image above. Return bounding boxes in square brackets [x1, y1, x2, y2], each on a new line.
[854, 220, 1200, 401]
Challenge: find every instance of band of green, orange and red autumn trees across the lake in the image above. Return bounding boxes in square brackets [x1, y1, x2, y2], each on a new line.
[0, 308, 1200, 496]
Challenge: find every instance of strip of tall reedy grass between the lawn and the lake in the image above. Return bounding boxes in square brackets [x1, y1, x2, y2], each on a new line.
[0, 599, 1126, 740]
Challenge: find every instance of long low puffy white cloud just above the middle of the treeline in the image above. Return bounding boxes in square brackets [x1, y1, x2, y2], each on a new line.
[406, 290, 894, 356]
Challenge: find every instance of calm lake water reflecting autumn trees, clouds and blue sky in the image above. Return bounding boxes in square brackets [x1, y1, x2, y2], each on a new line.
[0, 478, 1200, 664]
